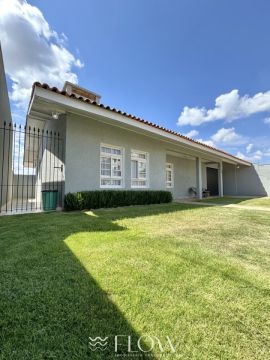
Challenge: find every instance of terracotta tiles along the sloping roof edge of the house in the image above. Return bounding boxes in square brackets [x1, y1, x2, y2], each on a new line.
[31, 82, 251, 164]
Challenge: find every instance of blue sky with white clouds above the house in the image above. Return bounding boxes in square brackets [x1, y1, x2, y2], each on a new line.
[0, 0, 270, 162]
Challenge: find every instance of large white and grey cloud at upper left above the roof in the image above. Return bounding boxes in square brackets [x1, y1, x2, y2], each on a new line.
[0, 0, 83, 108]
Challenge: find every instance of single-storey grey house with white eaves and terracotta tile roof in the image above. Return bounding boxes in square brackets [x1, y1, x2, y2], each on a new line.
[25, 82, 269, 210]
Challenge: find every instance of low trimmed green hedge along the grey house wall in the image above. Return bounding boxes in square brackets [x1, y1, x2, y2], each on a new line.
[65, 190, 172, 211]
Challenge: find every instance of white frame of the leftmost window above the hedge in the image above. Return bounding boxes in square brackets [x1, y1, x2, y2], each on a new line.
[99, 143, 125, 189]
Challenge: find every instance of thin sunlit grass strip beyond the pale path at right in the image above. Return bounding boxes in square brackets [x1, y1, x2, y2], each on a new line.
[196, 196, 270, 208]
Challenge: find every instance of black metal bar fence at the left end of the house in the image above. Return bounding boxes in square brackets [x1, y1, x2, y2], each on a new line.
[0, 123, 65, 214]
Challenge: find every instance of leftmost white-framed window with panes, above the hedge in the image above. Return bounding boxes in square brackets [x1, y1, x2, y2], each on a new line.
[100, 144, 123, 188]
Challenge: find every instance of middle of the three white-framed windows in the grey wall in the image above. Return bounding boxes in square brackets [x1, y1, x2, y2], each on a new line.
[131, 150, 149, 188]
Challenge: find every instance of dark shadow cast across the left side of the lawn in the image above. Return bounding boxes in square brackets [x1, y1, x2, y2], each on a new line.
[0, 204, 200, 360]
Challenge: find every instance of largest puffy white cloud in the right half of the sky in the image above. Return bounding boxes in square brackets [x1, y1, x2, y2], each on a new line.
[177, 89, 270, 126]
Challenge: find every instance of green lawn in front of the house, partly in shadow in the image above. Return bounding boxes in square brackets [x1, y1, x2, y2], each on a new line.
[0, 204, 270, 360]
